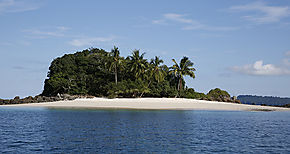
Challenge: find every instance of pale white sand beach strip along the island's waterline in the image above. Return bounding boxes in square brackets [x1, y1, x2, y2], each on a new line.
[4, 98, 290, 111]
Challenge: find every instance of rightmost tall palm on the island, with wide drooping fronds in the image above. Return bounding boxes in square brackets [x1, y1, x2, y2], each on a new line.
[169, 57, 195, 92]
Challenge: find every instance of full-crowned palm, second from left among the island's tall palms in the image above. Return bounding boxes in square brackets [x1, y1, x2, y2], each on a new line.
[129, 50, 148, 79]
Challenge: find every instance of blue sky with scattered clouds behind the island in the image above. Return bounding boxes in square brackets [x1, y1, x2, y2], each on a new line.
[0, 0, 290, 98]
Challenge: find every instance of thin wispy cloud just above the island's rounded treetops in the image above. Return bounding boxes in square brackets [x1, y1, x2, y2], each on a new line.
[69, 36, 116, 47]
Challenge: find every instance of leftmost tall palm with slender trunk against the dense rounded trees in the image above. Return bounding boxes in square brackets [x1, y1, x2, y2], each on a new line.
[110, 46, 122, 84]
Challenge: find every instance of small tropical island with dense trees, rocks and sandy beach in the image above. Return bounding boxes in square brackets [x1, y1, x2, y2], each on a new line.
[0, 46, 284, 111]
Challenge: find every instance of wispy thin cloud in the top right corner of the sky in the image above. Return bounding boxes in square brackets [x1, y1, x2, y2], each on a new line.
[230, 2, 290, 23]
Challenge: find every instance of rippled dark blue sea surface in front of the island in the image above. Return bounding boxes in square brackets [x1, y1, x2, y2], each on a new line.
[0, 107, 290, 153]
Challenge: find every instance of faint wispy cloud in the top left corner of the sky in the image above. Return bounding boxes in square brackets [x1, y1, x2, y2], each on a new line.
[0, 0, 40, 14]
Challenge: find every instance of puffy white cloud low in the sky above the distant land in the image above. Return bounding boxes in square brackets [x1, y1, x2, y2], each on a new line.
[231, 60, 290, 76]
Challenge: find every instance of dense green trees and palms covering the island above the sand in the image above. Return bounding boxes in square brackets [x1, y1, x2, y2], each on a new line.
[42, 47, 236, 100]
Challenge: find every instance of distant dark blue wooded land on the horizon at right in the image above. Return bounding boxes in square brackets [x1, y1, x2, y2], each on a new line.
[238, 95, 290, 106]
